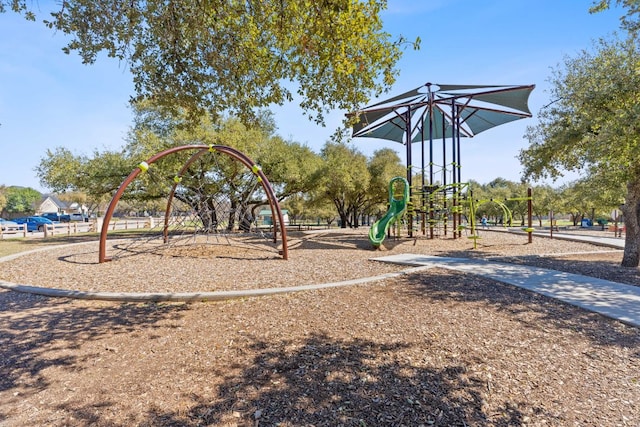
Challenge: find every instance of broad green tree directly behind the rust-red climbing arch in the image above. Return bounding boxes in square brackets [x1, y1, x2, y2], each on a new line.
[37, 102, 320, 228]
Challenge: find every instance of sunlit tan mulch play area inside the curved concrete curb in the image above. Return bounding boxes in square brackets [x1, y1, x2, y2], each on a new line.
[0, 227, 628, 299]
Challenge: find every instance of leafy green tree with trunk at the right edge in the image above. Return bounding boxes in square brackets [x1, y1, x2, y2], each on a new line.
[519, 38, 640, 267]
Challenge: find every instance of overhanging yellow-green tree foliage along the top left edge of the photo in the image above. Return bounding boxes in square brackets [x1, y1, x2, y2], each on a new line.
[0, 0, 420, 123]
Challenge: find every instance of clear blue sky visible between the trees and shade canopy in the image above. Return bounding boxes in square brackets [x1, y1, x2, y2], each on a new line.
[0, 0, 622, 192]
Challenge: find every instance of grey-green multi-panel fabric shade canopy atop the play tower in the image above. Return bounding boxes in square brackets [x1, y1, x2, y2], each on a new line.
[348, 83, 535, 144]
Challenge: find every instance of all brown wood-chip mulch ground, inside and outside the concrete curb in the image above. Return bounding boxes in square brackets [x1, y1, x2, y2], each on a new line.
[0, 229, 640, 427]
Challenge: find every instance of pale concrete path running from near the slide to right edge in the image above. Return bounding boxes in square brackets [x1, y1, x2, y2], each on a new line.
[375, 256, 640, 327]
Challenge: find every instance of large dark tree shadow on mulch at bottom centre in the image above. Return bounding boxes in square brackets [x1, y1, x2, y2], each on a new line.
[154, 334, 536, 426]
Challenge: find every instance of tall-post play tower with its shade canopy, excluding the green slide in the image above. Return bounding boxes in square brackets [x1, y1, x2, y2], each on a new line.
[347, 83, 535, 244]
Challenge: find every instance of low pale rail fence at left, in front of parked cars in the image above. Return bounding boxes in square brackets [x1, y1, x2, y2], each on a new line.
[0, 217, 158, 240]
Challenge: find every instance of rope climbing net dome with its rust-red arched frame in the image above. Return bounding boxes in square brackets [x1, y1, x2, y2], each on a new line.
[100, 146, 286, 262]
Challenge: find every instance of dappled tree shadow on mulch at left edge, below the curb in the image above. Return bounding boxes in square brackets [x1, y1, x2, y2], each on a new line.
[0, 291, 184, 396]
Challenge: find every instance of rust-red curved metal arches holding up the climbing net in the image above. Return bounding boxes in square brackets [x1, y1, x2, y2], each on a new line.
[98, 144, 289, 263]
